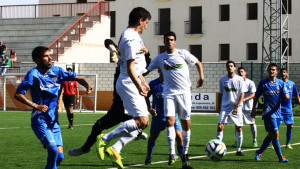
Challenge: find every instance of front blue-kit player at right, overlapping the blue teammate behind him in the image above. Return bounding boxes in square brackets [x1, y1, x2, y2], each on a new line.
[251, 63, 290, 163]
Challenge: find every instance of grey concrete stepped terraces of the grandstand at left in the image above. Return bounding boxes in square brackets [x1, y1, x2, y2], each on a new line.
[0, 16, 79, 62]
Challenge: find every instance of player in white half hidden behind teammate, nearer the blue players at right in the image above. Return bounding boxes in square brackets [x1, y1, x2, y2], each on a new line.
[232, 67, 257, 147]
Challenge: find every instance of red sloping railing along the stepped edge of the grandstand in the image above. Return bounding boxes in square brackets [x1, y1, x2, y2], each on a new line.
[48, 1, 110, 61]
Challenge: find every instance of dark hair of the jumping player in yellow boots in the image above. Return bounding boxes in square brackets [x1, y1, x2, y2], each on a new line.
[128, 7, 151, 26]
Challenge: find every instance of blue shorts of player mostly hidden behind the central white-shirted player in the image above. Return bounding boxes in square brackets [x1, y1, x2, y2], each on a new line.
[150, 116, 182, 134]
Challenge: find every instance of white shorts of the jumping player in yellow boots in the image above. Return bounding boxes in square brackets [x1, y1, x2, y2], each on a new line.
[116, 75, 149, 117]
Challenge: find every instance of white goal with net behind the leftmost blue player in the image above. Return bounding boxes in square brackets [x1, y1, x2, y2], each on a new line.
[0, 73, 97, 112]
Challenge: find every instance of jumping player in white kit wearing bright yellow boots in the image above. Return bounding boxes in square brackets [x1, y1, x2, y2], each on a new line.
[97, 7, 151, 168]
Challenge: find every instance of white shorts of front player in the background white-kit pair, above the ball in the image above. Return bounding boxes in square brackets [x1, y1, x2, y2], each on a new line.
[218, 105, 244, 127]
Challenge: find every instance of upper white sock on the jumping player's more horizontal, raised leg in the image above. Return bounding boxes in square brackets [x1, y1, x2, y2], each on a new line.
[102, 119, 139, 142]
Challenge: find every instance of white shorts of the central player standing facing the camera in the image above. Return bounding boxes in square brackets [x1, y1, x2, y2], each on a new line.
[164, 93, 192, 120]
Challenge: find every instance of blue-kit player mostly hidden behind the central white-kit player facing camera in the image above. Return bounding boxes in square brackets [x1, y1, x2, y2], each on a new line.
[145, 69, 183, 165]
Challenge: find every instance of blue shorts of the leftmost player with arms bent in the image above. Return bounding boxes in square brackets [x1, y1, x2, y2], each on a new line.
[31, 116, 63, 148]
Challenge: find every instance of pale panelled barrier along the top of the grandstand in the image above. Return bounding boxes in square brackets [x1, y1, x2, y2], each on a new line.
[0, 2, 108, 19]
